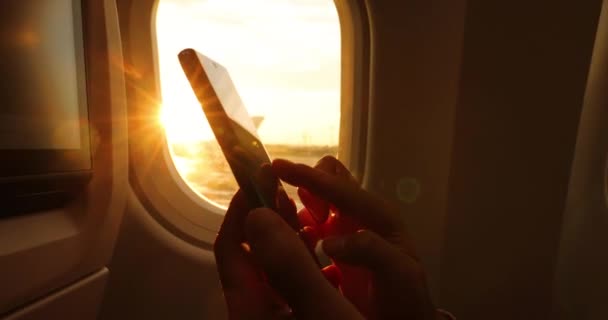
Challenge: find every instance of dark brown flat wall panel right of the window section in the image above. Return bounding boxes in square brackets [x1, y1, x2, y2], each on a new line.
[440, 0, 601, 319]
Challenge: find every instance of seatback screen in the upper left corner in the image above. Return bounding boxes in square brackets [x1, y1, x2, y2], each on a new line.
[0, 0, 88, 150]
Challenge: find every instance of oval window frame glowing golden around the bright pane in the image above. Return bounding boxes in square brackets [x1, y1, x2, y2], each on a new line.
[118, 0, 370, 248]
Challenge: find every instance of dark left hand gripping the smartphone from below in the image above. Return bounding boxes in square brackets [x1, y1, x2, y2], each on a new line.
[214, 167, 362, 320]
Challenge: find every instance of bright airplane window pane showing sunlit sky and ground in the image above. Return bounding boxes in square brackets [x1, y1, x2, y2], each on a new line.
[156, 0, 341, 207]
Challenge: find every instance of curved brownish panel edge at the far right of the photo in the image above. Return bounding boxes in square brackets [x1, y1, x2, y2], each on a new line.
[555, 1, 608, 320]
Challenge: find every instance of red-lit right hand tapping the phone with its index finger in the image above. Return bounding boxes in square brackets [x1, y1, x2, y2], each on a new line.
[272, 157, 441, 319]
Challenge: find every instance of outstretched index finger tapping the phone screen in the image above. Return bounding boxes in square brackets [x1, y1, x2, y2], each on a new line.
[272, 159, 404, 235]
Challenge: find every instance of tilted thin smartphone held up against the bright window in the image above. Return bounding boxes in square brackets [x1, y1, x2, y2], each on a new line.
[178, 49, 280, 209]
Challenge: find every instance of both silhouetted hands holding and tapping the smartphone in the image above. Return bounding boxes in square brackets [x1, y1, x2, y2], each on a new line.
[214, 157, 439, 320]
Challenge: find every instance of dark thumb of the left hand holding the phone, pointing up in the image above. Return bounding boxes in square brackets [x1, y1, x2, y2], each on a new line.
[245, 208, 360, 319]
